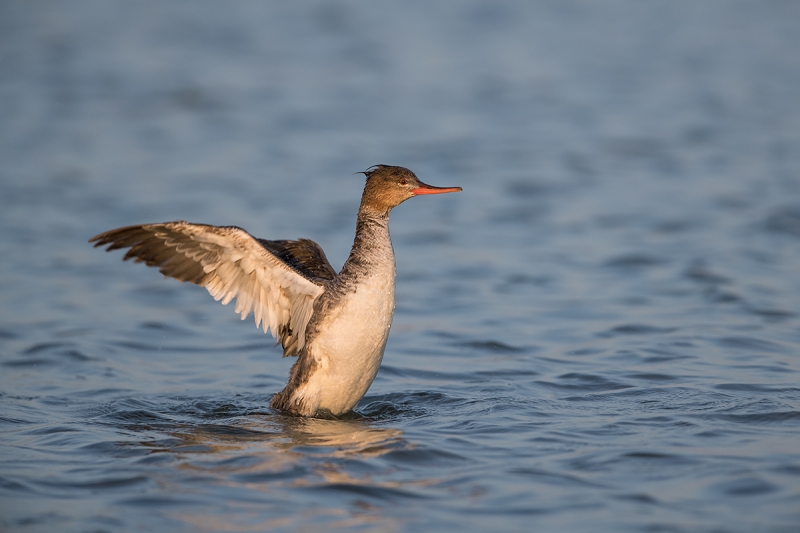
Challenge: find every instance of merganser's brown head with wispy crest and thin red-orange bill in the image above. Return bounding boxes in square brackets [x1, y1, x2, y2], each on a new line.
[361, 165, 461, 214]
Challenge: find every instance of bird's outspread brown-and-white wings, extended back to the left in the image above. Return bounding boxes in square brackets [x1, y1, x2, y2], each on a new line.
[89, 221, 335, 357]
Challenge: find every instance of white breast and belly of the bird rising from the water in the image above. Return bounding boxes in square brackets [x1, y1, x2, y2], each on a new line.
[296, 261, 395, 414]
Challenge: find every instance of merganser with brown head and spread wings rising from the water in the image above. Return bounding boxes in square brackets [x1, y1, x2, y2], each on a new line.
[89, 165, 461, 416]
